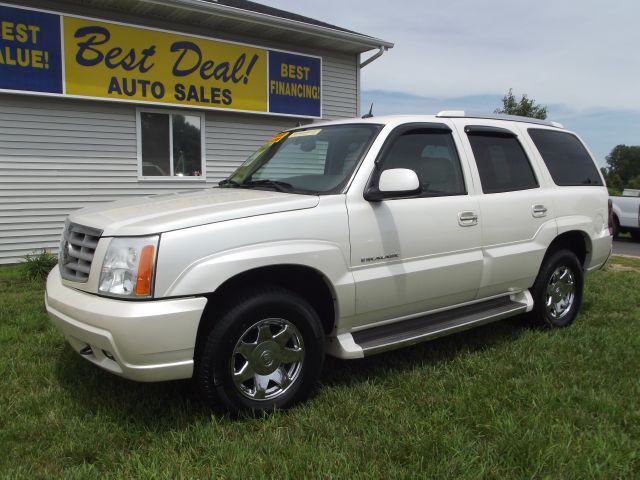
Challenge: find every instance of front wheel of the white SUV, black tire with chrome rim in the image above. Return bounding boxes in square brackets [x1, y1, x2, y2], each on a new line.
[195, 287, 324, 413]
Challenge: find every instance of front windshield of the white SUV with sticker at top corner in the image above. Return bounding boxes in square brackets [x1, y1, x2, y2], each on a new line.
[220, 124, 381, 195]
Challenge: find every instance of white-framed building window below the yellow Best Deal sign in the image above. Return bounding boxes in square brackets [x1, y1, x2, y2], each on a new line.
[137, 110, 205, 180]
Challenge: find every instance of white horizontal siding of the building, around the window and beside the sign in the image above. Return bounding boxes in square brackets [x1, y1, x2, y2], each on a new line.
[0, 51, 357, 264]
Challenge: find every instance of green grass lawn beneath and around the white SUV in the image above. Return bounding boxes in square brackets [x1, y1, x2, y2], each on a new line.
[0, 258, 640, 479]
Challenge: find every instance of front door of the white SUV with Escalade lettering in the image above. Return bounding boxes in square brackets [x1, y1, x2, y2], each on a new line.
[347, 123, 482, 328]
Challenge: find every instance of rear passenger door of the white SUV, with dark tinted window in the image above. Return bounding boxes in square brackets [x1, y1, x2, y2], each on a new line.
[462, 120, 557, 298]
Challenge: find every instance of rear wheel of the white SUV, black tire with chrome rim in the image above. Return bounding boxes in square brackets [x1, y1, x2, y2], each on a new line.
[531, 250, 584, 328]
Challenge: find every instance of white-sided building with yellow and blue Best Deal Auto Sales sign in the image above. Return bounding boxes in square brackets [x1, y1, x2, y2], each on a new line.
[0, 0, 393, 263]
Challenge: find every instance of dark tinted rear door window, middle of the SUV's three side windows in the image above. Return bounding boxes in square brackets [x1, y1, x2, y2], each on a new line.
[465, 127, 539, 193]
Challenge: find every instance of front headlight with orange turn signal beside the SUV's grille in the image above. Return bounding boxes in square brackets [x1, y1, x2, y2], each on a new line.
[98, 235, 159, 298]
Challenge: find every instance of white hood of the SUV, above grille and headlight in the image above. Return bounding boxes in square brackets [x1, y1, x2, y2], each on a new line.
[69, 188, 320, 237]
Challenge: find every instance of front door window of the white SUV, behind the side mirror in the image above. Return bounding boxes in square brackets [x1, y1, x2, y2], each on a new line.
[382, 129, 467, 197]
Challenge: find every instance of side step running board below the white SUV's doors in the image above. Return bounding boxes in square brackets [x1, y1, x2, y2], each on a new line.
[348, 291, 533, 356]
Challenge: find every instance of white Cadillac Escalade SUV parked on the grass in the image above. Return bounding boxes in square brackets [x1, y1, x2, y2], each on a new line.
[46, 112, 612, 411]
